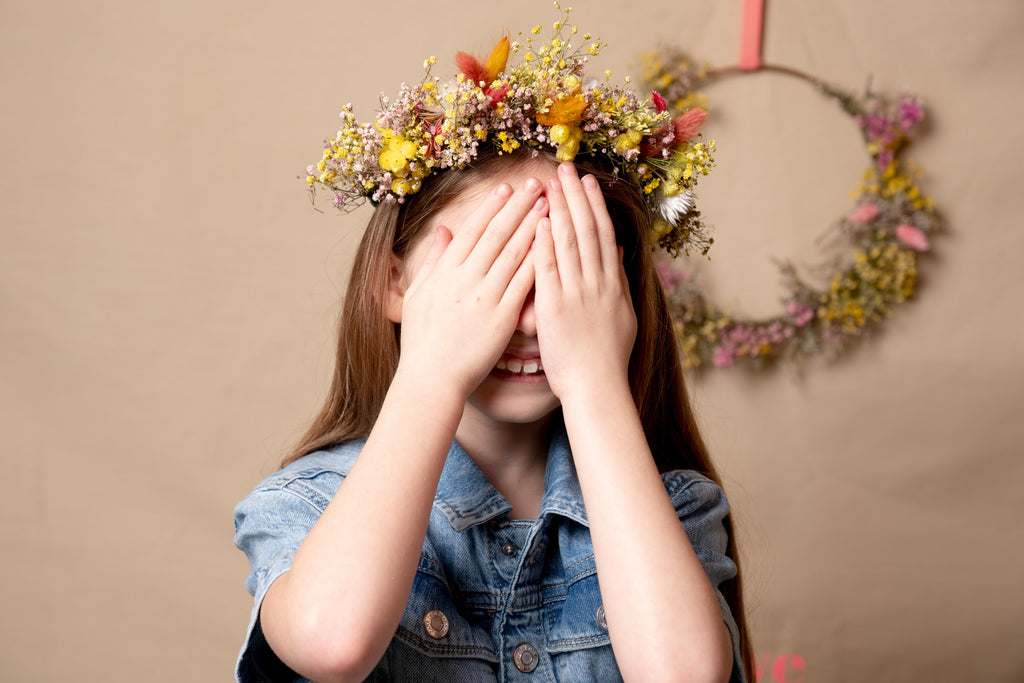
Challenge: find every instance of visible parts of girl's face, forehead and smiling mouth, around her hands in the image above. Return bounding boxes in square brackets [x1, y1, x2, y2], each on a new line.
[403, 161, 559, 426]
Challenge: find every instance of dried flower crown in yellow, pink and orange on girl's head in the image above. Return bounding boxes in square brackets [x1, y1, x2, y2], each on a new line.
[306, 2, 715, 256]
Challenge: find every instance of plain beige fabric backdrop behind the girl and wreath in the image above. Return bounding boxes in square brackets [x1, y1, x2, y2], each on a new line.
[0, 0, 1024, 683]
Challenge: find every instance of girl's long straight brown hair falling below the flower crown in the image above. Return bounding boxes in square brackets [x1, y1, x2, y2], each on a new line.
[283, 147, 754, 672]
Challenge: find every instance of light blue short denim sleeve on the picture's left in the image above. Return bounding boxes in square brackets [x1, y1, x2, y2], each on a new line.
[234, 461, 344, 683]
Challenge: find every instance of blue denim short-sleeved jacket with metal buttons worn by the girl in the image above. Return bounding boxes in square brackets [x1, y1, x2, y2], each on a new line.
[234, 432, 744, 683]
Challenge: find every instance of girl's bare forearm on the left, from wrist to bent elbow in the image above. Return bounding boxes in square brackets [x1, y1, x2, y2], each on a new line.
[261, 371, 464, 681]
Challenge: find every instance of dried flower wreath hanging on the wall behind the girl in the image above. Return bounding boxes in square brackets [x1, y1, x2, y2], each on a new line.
[643, 49, 940, 369]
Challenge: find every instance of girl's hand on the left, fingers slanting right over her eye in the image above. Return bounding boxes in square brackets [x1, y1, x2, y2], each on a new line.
[398, 178, 548, 400]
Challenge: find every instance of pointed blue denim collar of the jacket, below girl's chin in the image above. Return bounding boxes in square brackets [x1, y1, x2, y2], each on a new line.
[434, 426, 587, 532]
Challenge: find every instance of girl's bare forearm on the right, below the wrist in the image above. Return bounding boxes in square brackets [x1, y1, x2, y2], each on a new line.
[563, 380, 732, 681]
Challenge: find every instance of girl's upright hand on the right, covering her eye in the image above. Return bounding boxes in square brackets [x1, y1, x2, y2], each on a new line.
[535, 164, 637, 404]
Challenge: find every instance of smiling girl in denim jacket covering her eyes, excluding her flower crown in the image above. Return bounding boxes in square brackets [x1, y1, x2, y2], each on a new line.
[236, 21, 750, 682]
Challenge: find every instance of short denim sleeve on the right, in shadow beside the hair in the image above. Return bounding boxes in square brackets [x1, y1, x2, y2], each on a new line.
[665, 471, 746, 683]
